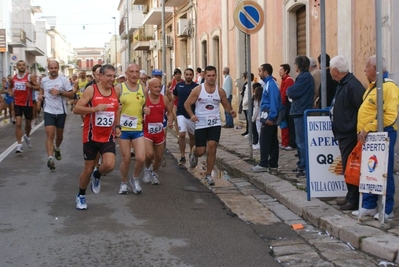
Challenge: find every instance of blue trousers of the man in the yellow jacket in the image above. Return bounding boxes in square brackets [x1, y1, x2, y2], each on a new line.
[363, 126, 397, 214]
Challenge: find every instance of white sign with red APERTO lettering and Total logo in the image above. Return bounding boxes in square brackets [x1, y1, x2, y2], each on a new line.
[359, 132, 389, 195]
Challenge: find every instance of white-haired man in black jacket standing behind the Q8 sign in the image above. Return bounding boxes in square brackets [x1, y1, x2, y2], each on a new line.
[330, 56, 364, 210]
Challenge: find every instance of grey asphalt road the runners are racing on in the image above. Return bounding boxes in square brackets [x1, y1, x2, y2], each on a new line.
[0, 114, 279, 267]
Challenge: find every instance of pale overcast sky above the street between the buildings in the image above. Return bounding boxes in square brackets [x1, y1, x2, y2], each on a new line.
[33, 0, 120, 48]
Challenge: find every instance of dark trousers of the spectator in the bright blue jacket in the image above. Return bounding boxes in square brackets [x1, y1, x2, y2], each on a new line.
[259, 124, 279, 168]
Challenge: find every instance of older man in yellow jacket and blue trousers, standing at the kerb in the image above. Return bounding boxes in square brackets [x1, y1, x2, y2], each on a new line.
[352, 55, 399, 219]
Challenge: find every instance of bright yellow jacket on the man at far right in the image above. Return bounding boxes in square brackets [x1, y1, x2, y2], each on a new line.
[357, 79, 399, 133]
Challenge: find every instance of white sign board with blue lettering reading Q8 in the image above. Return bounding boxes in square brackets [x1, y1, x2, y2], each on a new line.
[306, 116, 347, 200]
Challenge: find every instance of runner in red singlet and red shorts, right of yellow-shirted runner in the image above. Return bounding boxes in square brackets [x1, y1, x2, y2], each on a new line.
[143, 78, 173, 185]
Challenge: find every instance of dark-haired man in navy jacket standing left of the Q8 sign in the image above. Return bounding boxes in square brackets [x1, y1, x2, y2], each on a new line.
[287, 56, 314, 177]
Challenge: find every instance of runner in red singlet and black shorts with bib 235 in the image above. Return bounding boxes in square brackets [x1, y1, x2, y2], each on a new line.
[73, 65, 121, 210]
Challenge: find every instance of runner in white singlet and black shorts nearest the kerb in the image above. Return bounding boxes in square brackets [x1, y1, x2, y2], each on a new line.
[184, 66, 236, 185]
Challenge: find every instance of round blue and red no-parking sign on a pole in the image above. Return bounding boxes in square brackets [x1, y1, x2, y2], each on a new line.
[233, 1, 264, 34]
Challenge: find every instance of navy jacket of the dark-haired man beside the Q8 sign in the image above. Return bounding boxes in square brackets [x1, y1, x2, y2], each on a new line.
[287, 71, 314, 117]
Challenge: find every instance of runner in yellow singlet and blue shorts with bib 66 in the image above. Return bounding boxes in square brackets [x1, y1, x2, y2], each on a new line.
[115, 63, 148, 194]
